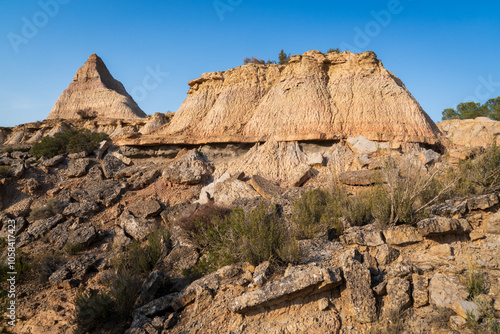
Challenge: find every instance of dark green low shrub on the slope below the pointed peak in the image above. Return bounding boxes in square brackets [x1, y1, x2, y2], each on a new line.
[30, 129, 109, 158]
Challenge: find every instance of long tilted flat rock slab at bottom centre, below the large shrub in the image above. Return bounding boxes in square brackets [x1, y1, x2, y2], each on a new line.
[229, 266, 342, 313]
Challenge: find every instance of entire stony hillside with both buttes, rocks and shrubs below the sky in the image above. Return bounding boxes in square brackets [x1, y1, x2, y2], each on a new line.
[0, 51, 500, 334]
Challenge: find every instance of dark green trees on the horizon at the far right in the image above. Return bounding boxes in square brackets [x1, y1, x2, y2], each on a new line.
[443, 96, 500, 121]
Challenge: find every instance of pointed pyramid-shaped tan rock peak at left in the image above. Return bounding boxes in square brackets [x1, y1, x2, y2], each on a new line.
[47, 53, 146, 119]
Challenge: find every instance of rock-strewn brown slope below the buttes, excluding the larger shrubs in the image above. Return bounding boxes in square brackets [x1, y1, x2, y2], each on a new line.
[0, 132, 500, 333]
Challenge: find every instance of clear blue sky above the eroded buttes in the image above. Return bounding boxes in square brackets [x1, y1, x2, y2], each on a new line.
[0, 0, 500, 126]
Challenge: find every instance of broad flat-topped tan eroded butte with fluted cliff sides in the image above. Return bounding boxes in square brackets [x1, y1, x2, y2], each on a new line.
[122, 51, 440, 145]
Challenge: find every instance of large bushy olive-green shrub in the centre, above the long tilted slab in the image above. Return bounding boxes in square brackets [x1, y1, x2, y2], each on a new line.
[192, 203, 300, 274]
